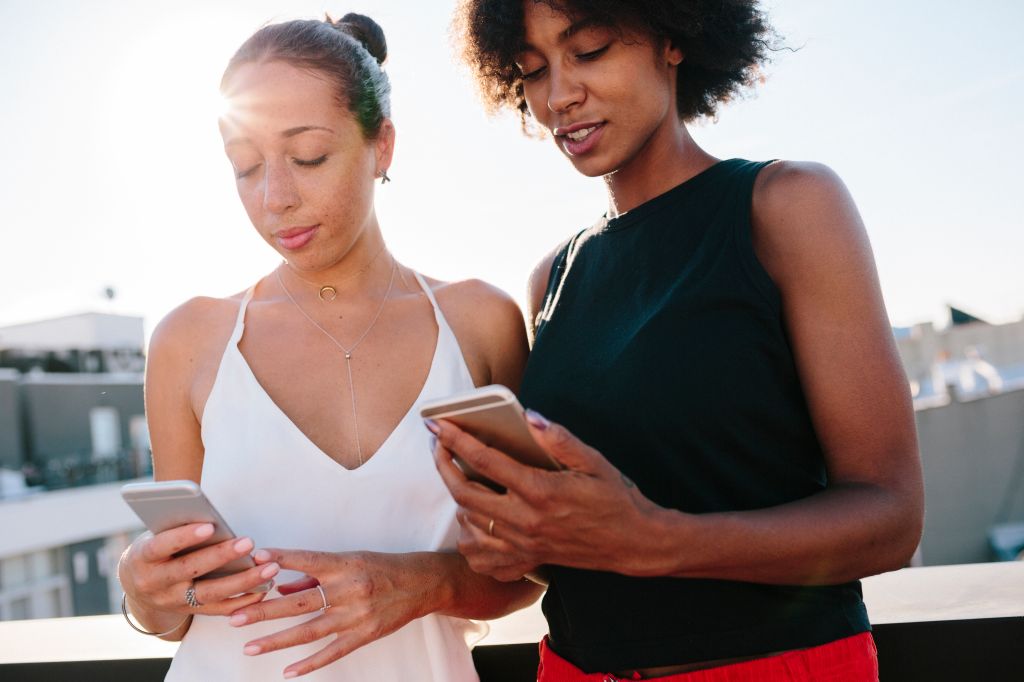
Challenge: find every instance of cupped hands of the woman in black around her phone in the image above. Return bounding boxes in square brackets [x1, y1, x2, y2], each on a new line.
[427, 413, 664, 581]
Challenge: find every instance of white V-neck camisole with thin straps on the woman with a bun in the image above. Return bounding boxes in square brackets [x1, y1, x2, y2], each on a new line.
[166, 273, 480, 682]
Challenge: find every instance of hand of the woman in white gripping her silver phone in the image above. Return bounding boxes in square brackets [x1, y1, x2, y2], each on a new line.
[118, 523, 281, 632]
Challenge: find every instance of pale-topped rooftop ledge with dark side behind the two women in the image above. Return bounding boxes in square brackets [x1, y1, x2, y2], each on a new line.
[0, 562, 1024, 682]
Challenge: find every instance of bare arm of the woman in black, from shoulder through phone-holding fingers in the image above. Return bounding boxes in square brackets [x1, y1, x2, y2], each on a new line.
[437, 164, 923, 585]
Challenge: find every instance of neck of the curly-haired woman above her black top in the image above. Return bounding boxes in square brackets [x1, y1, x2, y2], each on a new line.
[604, 121, 718, 218]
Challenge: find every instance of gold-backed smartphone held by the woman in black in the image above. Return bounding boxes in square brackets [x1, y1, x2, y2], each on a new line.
[420, 384, 562, 491]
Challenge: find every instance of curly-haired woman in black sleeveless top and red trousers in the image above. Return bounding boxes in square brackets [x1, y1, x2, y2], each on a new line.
[428, 0, 923, 681]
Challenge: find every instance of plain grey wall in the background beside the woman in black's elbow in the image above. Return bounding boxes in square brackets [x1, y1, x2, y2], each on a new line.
[916, 390, 1024, 565]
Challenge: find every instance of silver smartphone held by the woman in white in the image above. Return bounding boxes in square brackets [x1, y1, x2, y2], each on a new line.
[121, 480, 272, 592]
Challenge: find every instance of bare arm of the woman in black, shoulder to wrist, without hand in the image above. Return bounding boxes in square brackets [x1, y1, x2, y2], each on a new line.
[643, 163, 924, 584]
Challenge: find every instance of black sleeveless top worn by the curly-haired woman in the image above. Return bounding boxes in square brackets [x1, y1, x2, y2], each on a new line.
[520, 160, 870, 672]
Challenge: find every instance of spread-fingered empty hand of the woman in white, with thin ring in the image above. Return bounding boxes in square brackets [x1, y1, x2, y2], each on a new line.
[228, 549, 441, 678]
